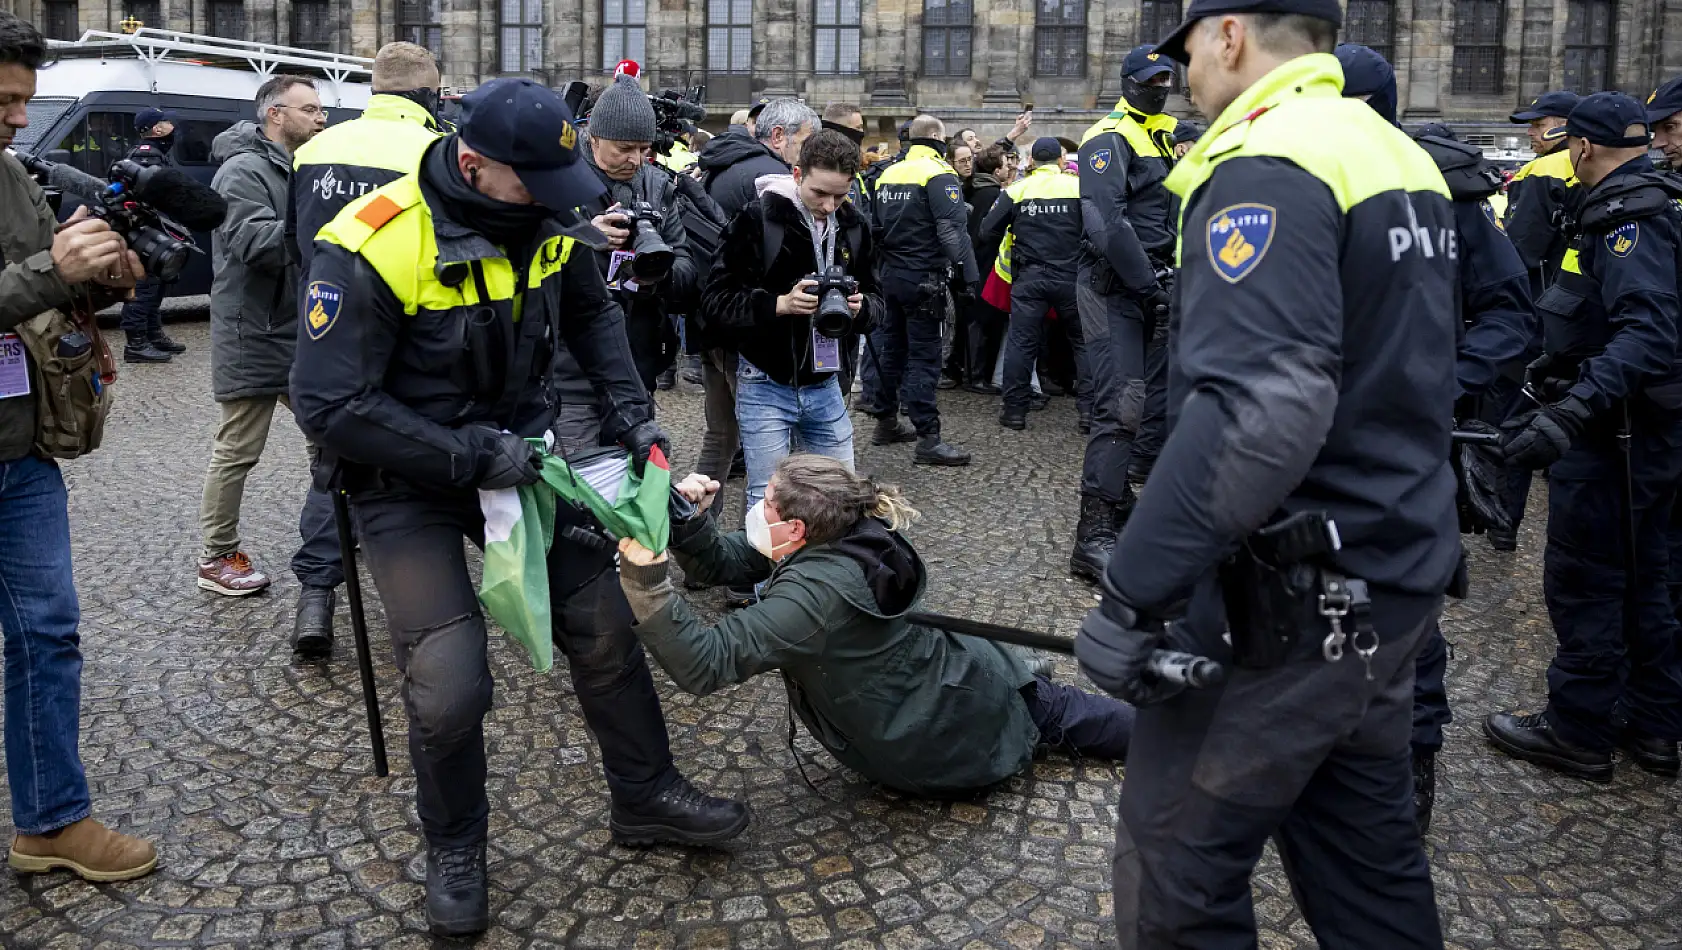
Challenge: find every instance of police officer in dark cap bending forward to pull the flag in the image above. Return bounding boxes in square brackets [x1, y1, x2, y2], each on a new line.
[293, 79, 748, 935]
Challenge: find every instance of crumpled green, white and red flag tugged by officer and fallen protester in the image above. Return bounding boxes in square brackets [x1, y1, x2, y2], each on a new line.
[479, 441, 671, 673]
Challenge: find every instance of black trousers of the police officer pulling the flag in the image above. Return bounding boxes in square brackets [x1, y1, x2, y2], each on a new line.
[352, 481, 678, 847]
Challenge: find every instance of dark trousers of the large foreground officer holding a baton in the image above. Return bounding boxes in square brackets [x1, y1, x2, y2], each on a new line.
[1113, 594, 1443, 950]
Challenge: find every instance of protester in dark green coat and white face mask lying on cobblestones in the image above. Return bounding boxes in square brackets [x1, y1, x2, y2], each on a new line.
[619, 454, 1134, 797]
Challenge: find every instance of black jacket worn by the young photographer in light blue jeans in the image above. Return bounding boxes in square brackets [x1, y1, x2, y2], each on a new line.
[701, 180, 883, 387]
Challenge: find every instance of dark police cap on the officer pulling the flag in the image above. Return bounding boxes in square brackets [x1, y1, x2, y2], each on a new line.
[458, 79, 606, 212]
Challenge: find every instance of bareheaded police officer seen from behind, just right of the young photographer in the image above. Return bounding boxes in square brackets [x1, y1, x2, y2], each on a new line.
[865, 116, 981, 466]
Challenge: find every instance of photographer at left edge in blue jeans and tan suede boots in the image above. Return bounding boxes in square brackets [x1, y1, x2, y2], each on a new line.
[0, 13, 158, 881]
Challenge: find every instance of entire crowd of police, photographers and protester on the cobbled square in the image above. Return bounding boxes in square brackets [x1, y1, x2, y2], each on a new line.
[0, 0, 1682, 948]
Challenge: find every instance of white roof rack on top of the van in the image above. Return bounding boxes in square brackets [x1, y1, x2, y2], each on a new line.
[52, 27, 373, 82]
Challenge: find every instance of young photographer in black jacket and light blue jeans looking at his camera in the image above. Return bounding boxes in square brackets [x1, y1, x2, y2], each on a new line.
[701, 129, 881, 506]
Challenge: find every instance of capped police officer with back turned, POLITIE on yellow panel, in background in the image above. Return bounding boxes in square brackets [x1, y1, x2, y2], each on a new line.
[976, 136, 1087, 429]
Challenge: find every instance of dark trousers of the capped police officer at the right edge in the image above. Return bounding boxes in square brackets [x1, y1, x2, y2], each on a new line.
[1542, 420, 1682, 752]
